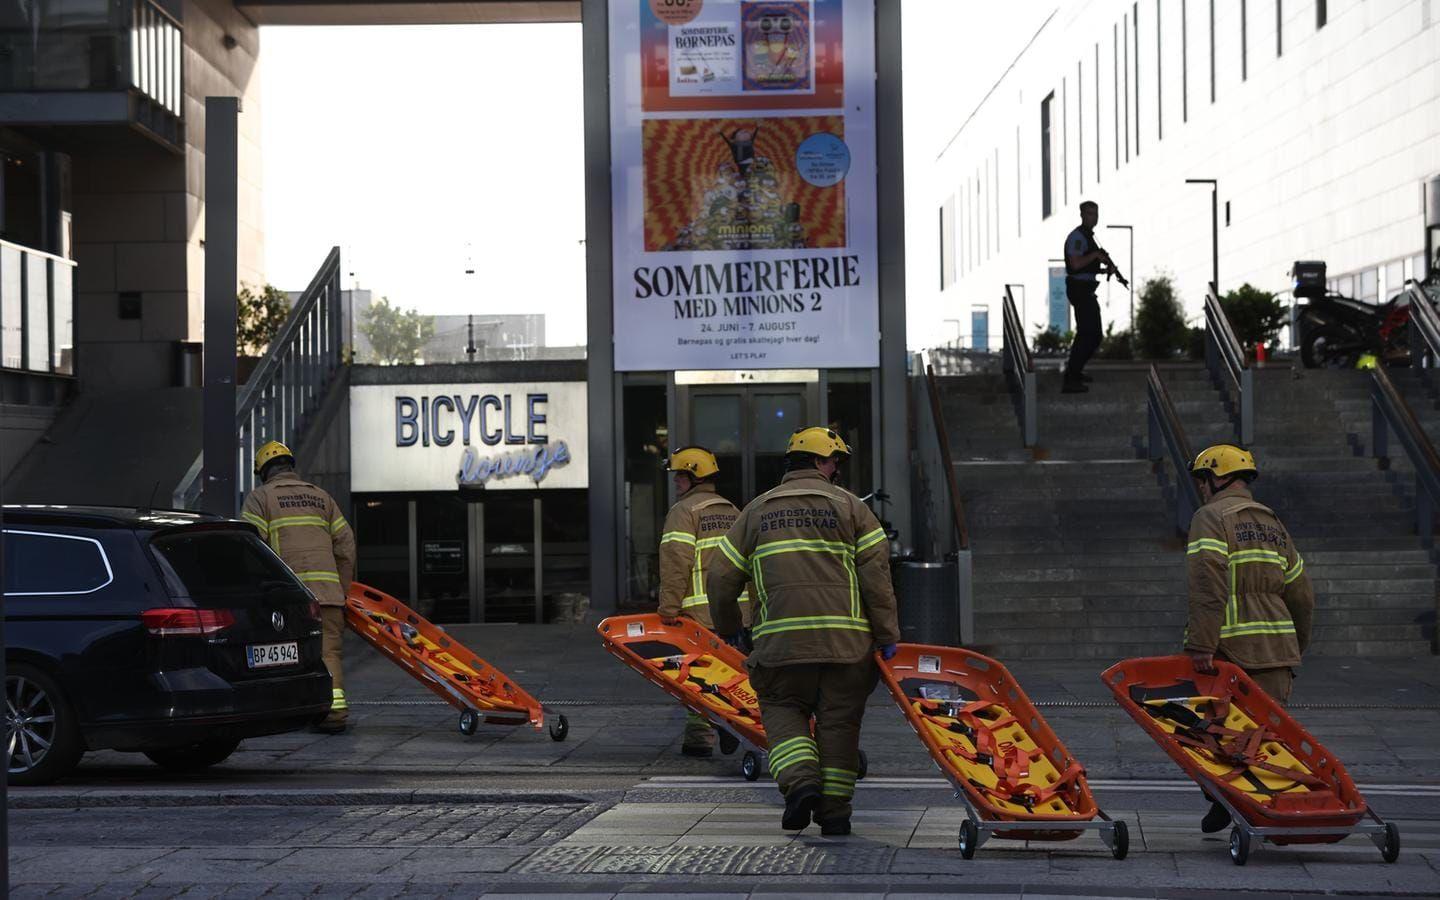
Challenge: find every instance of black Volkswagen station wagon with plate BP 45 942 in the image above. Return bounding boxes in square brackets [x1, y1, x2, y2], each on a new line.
[0, 505, 330, 785]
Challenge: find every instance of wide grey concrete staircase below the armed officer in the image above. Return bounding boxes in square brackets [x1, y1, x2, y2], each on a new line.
[940, 364, 1440, 661]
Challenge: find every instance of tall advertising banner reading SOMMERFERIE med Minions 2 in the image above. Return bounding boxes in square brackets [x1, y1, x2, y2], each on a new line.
[609, 0, 880, 372]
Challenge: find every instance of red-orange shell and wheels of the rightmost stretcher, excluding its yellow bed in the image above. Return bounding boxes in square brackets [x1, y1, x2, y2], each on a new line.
[1100, 655, 1400, 865]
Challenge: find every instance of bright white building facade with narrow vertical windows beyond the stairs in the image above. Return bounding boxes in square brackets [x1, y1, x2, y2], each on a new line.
[927, 0, 1440, 347]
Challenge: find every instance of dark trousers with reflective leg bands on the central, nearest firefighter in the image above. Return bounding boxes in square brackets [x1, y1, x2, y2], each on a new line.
[750, 657, 880, 822]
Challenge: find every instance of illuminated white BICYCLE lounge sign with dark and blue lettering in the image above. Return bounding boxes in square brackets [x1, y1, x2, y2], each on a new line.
[350, 382, 589, 492]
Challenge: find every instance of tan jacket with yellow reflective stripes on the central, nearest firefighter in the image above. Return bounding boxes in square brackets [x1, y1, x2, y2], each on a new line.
[707, 469, 900, 665]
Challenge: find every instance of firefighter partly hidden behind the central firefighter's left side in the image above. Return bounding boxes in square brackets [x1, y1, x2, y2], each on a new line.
[657, 446, 750, 756]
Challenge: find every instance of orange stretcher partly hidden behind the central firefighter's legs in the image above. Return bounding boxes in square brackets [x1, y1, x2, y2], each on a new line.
[596, 612, 867, 782]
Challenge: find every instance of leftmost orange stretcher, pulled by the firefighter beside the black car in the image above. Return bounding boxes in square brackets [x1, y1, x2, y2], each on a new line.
[346, 582, 570, 740]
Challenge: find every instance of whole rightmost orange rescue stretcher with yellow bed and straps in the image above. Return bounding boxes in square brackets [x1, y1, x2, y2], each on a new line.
[1102, 655, 1400, 865]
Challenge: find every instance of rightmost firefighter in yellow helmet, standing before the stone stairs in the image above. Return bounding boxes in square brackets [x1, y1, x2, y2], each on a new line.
[1185, 444, 1315, 834]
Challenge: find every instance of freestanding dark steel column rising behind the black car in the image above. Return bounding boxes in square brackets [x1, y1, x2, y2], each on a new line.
[200, 96, 240, 516]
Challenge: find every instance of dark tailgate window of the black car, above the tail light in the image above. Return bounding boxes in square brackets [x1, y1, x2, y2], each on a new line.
[150, 528, 305, 605]
